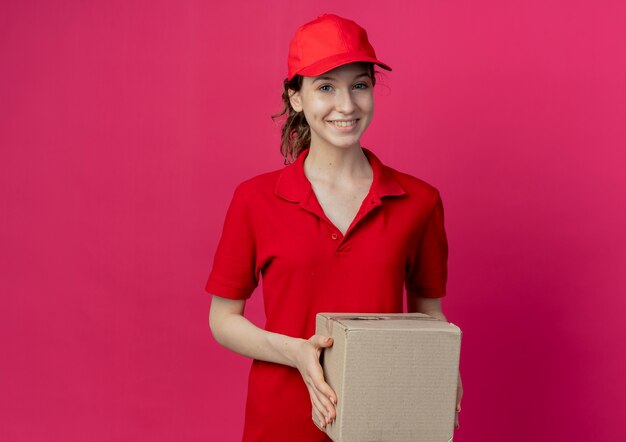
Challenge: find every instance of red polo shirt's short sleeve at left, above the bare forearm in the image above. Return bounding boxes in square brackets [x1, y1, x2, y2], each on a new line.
[205, 186, 259, 299]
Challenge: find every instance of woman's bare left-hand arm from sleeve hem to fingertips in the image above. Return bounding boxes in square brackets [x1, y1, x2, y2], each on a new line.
[209, 295, 337, 424]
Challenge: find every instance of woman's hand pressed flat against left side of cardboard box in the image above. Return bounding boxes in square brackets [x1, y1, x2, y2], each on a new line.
[295, 335, 337, 428]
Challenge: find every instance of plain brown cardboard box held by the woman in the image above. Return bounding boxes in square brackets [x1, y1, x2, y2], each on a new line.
[313, 313, 462, 442]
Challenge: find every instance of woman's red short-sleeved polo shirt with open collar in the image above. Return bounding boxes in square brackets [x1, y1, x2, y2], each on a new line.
[206, 149, 448, 442]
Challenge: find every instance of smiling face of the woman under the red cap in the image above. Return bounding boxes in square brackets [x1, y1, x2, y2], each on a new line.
[290, 63, 374, 152]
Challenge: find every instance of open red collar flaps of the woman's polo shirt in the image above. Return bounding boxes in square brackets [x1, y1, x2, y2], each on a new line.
[274, 148, 405, 203]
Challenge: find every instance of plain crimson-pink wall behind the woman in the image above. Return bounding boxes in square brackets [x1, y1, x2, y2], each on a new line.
[0, 0, 626, 442]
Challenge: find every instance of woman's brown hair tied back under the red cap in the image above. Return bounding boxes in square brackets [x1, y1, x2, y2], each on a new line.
[272, 63, 379, 164]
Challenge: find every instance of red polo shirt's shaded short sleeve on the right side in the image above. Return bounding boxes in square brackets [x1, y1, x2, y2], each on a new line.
[406, 194, 448, 298]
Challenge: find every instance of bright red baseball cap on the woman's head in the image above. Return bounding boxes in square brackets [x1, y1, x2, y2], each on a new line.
[287, 14, 391, 80]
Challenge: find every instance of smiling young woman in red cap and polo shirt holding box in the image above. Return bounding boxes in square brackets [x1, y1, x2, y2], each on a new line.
[206, 14, 462, 442]
